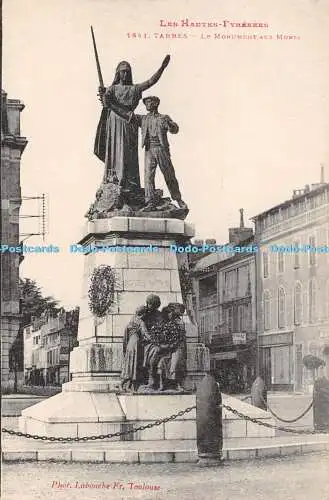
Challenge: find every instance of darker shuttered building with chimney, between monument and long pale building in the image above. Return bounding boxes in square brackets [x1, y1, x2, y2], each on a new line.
[193, 213, 256, 393]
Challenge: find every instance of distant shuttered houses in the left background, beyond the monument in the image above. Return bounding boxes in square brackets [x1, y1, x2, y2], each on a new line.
[24, 308, 79, 386]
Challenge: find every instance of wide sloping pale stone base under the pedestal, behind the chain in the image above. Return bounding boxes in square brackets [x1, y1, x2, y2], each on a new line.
[19, 391, 274, 442]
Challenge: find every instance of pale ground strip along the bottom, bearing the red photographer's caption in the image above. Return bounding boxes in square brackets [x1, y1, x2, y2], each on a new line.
[2, 453, 329, 500]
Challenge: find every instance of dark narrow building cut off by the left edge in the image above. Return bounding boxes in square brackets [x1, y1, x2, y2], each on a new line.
[0, 91, 27, 388]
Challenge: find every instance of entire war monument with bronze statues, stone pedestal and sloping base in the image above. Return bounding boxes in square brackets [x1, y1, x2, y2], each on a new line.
[20, 37, 272, 456]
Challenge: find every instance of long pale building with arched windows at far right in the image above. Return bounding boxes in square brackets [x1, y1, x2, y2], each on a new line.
[253, 179, 329, 391]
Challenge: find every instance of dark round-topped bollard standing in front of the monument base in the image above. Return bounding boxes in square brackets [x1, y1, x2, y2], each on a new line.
[196, 374, 223, 466]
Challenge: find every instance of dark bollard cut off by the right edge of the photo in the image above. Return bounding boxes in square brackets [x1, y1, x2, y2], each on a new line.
[313, 377, 329, 432]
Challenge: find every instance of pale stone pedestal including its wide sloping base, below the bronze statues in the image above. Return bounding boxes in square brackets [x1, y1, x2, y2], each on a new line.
[20, 217, 209, 439]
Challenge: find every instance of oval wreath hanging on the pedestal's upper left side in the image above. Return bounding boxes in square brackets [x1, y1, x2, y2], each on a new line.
[88, 265, 115, 318]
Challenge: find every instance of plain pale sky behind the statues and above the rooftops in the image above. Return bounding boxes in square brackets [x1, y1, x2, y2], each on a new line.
[3, 0, 329, 307]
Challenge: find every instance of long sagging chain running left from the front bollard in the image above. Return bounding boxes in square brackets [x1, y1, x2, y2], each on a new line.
[1, 406, 196, 443]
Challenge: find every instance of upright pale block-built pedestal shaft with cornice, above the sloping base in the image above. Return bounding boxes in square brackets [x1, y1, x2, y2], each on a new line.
[63, 217, 209, 392]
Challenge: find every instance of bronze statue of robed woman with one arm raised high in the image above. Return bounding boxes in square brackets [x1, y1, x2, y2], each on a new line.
[94, 55, 170, 191]
